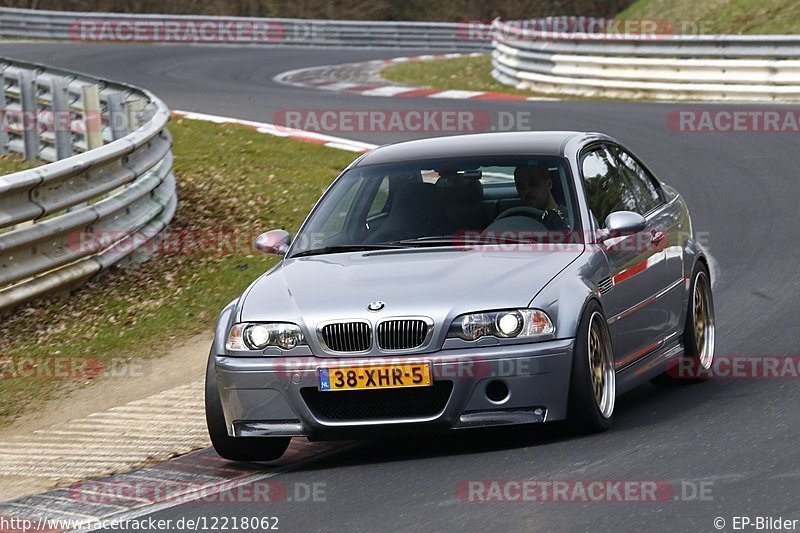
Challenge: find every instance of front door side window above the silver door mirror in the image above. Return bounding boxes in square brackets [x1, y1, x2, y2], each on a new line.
[581, 147, 638, 227]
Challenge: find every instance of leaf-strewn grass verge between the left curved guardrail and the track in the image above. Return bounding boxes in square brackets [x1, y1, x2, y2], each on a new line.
[0, 119, 355, 425]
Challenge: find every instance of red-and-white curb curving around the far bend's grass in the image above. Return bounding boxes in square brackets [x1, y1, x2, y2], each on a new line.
[273, 53, 558, 101]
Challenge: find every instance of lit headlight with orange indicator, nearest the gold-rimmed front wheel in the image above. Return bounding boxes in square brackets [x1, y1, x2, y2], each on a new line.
[448, 309, 555, 341]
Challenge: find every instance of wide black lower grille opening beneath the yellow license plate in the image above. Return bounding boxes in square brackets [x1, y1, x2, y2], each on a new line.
[300, 381, 453, 420]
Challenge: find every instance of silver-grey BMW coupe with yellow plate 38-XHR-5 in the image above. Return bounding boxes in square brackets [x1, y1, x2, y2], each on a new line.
[205, 132, 715, 461]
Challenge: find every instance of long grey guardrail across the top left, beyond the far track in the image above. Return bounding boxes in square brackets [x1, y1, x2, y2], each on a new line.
[0, 8, 491, 51]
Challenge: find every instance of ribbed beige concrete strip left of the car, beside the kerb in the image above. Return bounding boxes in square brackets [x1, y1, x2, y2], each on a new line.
[0, 381, 210, 500]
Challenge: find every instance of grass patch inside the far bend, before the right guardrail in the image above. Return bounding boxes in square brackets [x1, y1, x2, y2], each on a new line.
[381, 54, 544, 96]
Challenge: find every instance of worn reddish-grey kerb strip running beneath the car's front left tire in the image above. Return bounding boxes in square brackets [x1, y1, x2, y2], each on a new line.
[0, 439, 353, 533]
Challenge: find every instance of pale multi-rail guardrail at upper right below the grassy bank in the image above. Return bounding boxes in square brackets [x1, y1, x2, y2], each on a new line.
[492, 20, 800, 102]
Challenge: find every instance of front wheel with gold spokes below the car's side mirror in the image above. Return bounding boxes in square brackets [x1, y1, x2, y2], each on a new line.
[567, 300, 616, 434]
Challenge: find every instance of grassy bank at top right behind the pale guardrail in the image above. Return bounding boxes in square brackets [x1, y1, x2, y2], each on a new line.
[618, 0, 800, 34]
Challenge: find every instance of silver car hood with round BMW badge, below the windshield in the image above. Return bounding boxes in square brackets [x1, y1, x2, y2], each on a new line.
[240, 245, 583, 324]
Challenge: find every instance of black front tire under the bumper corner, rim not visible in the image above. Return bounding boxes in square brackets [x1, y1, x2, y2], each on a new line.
[205, 354, 291, 461]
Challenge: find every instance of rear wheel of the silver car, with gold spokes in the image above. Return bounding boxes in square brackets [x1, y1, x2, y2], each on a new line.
[652, 261, 716, 385]
